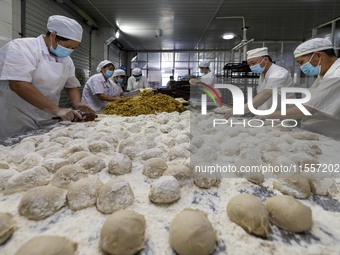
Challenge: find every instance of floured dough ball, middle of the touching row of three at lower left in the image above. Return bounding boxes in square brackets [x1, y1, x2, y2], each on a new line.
[67, 178, 102, 211]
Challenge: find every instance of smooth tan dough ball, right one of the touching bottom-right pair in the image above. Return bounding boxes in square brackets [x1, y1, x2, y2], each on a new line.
[265, 195, 313, 233]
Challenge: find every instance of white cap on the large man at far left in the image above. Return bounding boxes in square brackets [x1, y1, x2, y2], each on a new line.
[47, 15, 83, 42]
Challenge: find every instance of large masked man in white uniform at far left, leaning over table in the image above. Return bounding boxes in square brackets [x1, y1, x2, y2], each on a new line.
[0, 15, 93, 138]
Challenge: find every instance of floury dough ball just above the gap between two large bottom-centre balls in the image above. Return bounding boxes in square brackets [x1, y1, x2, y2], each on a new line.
[149, 176, 181, 204]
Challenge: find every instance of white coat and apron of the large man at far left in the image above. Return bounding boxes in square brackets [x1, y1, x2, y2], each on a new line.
[0, 35, 80, 138]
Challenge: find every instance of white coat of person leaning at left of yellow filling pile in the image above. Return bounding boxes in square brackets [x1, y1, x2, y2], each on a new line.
[81, 73, 123, 111]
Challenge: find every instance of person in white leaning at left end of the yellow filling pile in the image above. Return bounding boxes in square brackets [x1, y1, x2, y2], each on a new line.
[81, 60, 121, 112]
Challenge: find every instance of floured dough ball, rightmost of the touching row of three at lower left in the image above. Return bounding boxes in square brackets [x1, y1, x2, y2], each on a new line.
[97, 178, 134, 214]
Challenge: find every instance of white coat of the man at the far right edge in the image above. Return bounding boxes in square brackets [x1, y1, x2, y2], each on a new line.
[301, 59, 340, 140]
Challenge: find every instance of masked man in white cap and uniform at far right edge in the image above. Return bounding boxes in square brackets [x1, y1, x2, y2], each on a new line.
[266, 38, 340, 140]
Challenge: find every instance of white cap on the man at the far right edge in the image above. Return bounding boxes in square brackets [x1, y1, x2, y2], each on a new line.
[294, 38, 333, 58]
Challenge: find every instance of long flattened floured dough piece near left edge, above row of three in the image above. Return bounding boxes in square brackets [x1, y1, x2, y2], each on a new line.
[5, 166, 52, 194]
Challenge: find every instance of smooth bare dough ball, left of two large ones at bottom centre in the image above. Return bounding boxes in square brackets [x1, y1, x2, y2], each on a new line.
[100, 210, 145, 255]
